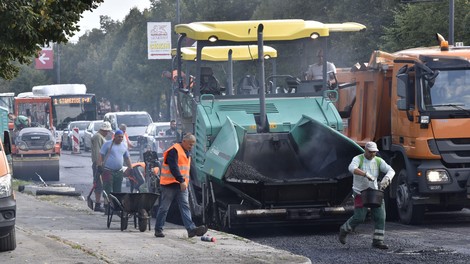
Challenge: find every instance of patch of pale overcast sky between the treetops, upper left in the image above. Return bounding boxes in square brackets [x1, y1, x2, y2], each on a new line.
[71, 0, 150, 41]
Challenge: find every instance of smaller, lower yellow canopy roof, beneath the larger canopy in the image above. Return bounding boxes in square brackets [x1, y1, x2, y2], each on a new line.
[171, 45, 277, 61]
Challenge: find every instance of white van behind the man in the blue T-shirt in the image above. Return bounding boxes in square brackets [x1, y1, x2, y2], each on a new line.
[103, 111, 153, 151]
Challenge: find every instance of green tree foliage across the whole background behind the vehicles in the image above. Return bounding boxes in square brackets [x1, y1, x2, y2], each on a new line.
[0, 0, 470, 119]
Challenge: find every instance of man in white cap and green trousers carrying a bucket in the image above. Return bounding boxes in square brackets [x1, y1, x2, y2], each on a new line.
[339, 141, 395, 249]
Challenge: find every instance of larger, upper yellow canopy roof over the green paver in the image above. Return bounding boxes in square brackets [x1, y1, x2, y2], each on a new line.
[175, 19, 366, 42]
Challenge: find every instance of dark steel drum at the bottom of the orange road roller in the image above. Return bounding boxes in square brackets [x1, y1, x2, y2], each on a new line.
[13, 158, 60, 181]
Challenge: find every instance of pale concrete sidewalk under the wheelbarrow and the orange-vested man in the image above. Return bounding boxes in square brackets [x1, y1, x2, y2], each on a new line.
[9, 193, 311, 264]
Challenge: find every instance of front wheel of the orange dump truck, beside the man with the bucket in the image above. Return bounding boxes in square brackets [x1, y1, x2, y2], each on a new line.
[397, 169, 425, 225]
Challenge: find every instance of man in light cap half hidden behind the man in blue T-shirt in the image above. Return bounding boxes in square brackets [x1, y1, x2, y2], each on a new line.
[91, 121, 111, 212]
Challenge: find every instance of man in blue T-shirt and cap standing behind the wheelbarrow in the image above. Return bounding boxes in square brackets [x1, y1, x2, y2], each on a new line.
[98, 130, 132, 211]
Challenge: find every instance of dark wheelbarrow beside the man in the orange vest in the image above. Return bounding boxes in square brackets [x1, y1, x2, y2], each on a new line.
[106, 193, 159, 232]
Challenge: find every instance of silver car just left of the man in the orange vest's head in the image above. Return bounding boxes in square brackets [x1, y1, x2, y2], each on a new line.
[139, 122, 176, 160]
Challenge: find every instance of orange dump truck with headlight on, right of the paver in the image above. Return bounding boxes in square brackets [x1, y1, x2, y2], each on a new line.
[336, 38, 470, 224]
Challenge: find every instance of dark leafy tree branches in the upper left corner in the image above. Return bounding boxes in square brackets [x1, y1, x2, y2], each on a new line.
[0, 0, 104, 79]
